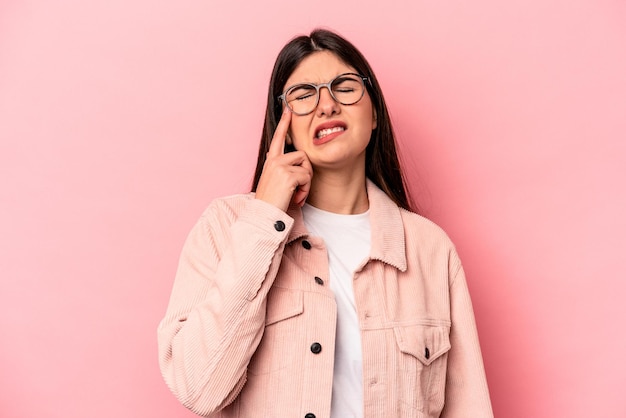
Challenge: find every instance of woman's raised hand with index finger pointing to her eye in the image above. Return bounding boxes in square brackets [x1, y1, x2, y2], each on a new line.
[256, 106, 313, 212]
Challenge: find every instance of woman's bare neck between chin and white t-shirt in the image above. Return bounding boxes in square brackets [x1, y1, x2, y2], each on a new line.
[307, 170, 369, 215]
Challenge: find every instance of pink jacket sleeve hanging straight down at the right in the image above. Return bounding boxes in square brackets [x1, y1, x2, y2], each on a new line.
[441, 251, 493, 418]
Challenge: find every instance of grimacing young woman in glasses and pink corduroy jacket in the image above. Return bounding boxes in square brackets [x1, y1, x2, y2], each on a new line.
[158, 30, 493, 418]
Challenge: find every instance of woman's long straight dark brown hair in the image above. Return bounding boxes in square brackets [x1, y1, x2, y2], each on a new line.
[252, 29, 416, 211]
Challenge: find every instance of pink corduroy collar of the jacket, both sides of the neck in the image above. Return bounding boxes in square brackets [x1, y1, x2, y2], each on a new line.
[287, 179, 407, 271]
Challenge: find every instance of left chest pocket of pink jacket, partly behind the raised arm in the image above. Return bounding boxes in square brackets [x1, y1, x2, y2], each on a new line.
[248, 287, 304, 375]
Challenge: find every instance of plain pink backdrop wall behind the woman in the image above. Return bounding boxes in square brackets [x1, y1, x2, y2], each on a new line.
[0, 0, 626, 418]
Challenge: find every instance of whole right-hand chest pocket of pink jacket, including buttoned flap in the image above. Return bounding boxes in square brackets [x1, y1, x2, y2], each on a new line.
[394, 324, 450, 416]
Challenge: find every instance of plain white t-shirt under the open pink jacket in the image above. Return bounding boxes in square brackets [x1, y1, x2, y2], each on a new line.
[302, 204, 371, 418]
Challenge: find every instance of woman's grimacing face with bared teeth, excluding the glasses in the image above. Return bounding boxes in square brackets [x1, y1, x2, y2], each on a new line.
[283, 51, 376, 171]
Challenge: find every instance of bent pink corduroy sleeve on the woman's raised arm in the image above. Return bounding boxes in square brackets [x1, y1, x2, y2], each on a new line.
[158, 198, 293, 416]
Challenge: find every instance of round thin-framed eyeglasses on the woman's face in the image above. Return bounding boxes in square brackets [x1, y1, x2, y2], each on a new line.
[278, 73, 369, 116]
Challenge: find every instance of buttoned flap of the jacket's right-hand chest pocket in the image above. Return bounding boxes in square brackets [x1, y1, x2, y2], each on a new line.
[393, 324, 450, 366]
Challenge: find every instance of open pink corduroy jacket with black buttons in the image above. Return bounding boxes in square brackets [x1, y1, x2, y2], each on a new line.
[158, 180, 493, 418]
